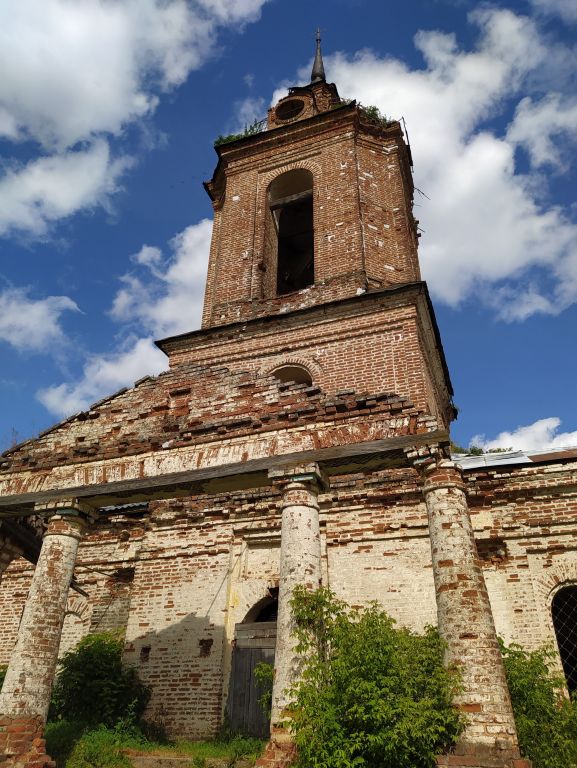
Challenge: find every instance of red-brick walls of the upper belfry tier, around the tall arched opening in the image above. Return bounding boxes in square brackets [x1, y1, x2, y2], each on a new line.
[203, 105, 420, 327]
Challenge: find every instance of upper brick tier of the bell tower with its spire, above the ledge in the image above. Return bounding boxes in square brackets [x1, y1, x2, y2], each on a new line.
[203, 37, 420, 328]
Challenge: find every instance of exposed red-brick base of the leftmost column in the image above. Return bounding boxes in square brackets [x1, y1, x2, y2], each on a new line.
[0, 715, 56, 768]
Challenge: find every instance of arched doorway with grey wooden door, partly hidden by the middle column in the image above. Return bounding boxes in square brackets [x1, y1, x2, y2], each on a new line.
[226, 588, 278, 738]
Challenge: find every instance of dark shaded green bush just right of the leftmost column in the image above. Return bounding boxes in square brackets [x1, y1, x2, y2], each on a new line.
[50, 632, 150, 726]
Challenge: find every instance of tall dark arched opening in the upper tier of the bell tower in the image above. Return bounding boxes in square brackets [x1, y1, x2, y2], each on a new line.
[268, 168, 315, 296]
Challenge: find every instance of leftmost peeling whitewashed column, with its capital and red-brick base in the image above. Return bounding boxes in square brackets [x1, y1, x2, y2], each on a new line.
[0, 500, 91, 766]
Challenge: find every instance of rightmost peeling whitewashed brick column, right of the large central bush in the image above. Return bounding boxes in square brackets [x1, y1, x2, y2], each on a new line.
[423, 460, 529, 768]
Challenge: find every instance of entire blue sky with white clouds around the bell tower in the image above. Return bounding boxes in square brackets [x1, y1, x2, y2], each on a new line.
[0, 0, 577, 449]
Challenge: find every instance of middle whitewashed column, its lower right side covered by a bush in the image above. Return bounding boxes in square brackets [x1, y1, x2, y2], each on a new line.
[269, 464, 324, 729]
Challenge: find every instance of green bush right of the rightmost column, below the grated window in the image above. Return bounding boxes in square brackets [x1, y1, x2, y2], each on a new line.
[501, 644, 577, 768]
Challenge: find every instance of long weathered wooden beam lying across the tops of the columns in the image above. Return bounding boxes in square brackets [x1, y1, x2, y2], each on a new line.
[0, 430, 449, 517]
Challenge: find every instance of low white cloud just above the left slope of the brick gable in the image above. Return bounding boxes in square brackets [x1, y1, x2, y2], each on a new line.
[36, 338, 166, 417]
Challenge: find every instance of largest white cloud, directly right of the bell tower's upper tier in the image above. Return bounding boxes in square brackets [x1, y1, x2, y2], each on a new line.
[280, 8, 577, 320]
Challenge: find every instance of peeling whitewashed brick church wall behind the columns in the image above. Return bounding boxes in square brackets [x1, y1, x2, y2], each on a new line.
[0, 462, 577, 737]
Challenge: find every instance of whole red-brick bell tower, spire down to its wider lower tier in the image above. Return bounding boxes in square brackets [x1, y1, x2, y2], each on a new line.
[158, 34, 454, 428]
